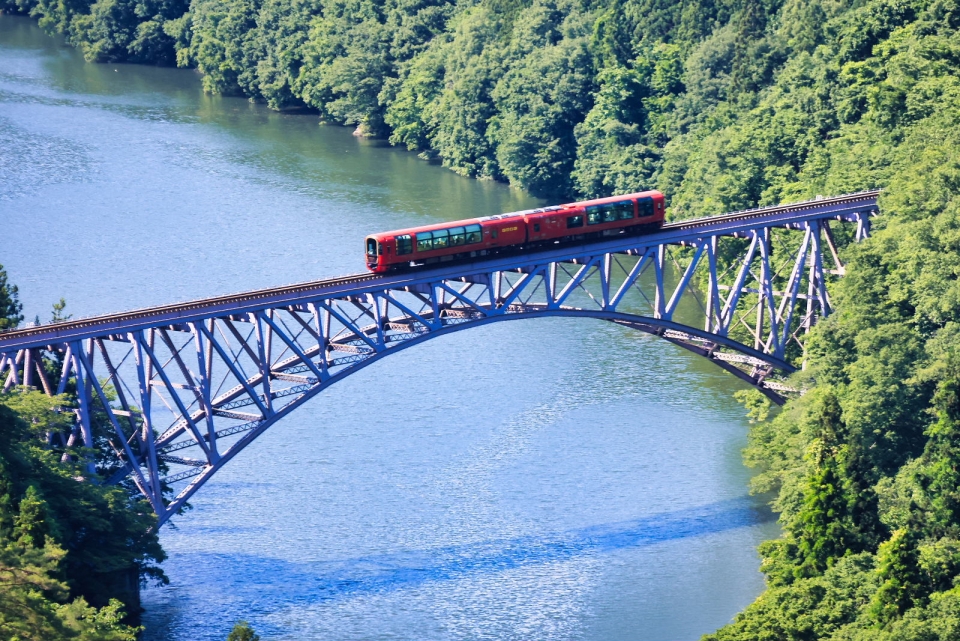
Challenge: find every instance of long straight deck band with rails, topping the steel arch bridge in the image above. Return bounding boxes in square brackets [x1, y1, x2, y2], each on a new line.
[0, 190, 880, 351]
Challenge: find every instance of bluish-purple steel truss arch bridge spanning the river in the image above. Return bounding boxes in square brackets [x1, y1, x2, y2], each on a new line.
[0, 191, 879, 524]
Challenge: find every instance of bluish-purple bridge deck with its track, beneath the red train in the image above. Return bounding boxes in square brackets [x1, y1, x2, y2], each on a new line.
[0, 190, 880, 352]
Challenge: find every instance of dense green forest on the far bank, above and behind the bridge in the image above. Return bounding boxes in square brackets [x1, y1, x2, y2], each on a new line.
[0, 0, 956, 205]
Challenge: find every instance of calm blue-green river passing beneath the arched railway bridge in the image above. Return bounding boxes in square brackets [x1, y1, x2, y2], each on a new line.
[0, 15, 777, 641]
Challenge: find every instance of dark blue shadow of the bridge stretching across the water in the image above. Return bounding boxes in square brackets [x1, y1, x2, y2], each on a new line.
[154, 497, 776, 616]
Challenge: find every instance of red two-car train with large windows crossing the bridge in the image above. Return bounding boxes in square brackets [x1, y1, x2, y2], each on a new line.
[366, 191, 663, 274]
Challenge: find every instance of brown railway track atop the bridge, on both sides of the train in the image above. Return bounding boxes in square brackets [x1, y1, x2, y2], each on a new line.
[0, 190, 880, 349]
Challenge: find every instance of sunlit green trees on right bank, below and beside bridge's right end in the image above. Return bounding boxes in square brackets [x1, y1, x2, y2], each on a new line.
[708, 175, 960, 641]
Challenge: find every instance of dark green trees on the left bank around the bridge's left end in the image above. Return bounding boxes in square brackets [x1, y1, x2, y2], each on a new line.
[0, 267, 165, 641]
